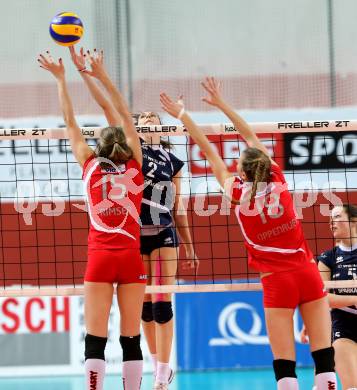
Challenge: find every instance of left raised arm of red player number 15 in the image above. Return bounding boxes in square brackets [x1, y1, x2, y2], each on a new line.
[37, 52, 94, 166]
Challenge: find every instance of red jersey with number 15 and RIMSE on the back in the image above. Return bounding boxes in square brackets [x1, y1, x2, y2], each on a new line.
[83, 156, 144, 250]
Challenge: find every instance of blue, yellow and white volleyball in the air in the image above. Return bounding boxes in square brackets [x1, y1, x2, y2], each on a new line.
[50, 12, 83, 46]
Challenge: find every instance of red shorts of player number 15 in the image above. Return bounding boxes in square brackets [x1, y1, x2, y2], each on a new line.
[84, 249, 147, 284]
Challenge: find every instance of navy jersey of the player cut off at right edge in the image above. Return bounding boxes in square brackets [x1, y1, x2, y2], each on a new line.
[317, 245, 357, 314]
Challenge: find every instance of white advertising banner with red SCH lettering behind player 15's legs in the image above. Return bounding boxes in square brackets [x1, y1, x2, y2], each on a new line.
[0, 297, 176, 377]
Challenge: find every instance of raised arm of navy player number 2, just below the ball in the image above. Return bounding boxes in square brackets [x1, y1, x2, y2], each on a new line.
[69, 46, 123, 126]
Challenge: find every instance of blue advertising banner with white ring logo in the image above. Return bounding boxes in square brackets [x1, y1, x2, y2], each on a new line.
[176, 291, 312, 370]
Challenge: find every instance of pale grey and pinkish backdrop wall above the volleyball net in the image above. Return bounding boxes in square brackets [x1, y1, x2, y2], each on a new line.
[0, 0, 357, 119]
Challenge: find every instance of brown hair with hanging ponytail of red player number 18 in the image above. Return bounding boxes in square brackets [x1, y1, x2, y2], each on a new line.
[242, 148, 271, 200]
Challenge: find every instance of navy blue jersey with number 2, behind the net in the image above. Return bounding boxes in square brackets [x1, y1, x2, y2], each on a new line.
[140, 142, 184, 226]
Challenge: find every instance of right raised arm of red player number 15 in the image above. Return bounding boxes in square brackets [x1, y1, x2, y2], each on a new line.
[83, 51, 142, 165]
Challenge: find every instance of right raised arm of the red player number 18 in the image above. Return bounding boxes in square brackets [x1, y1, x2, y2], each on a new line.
[201, 77, 269, 161]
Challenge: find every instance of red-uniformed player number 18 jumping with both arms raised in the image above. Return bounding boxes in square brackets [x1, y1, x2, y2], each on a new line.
[160, 78, 336, 390]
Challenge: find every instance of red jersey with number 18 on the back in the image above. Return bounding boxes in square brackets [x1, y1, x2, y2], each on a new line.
[232, 164, 313, 272]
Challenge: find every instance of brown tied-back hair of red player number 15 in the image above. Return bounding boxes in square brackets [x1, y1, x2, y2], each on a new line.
[95, 126, 133, 166]
